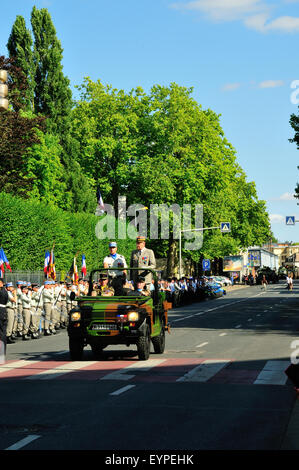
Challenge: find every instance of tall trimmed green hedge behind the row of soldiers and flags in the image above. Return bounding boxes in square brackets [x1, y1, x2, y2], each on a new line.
[0, 193, 135, 272]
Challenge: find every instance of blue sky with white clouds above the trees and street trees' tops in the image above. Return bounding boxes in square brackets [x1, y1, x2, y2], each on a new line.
[0, 0, 299, 242]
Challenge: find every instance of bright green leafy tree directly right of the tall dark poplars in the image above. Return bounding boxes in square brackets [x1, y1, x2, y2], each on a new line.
[71, 78, 143, 207]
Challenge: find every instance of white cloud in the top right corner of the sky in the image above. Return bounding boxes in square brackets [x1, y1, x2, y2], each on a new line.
[171, 0, 299, 33]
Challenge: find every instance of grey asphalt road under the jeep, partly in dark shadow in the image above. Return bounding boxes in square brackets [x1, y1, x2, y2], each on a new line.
[0, 281, 299, 455]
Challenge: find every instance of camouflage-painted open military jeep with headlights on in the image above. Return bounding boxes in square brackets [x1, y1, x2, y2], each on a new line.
[67, 268, 172, 361]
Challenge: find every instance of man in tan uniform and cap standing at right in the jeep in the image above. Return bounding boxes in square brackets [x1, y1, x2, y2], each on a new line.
[130, 236, 156, 290]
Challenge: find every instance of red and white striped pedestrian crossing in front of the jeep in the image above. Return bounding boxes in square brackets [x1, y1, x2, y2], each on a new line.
[0, 358, 290, 385]
